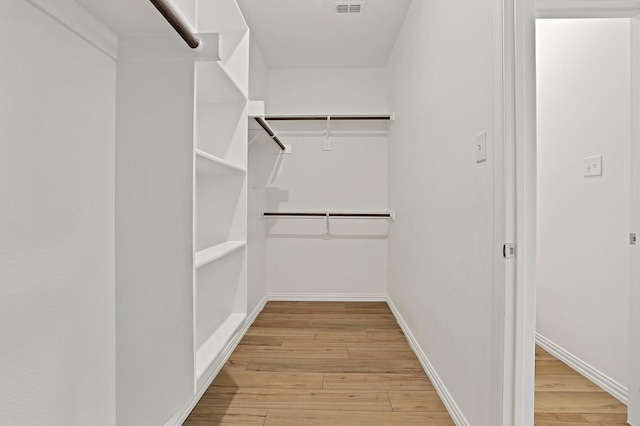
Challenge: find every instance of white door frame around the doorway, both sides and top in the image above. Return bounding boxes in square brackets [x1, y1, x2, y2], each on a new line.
[503, 0, 640, 426]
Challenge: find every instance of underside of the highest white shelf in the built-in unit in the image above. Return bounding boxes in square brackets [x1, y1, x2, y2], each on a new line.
[196, 61, 247, 102]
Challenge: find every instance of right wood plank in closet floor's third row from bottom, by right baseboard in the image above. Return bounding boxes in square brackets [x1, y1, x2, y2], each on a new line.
[323, 373, 435, 391]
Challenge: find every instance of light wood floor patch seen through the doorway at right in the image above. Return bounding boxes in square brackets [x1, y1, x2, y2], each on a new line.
[535, 346, 628, 426]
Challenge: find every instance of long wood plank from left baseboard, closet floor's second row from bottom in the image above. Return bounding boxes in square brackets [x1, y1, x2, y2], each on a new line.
[198, 387, 391, 411]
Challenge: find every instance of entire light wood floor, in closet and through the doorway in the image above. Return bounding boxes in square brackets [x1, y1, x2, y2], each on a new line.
[185, 302, 627, 426]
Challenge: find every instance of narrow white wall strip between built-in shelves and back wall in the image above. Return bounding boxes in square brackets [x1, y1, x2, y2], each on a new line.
[247, 37, 270, 314]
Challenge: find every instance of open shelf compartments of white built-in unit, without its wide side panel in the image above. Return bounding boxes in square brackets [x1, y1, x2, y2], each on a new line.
[193, 5, 249, 393]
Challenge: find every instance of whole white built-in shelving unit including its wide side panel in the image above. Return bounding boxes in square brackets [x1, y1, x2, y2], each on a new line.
[115, 0, 249, 425]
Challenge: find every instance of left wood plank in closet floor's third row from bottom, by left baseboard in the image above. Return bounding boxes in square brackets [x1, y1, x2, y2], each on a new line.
[211, 368, 323, 389]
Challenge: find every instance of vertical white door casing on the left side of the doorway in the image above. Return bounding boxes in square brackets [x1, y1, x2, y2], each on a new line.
[505, 0, 536, 426]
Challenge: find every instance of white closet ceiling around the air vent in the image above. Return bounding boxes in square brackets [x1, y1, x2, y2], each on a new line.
[238, 0, 411, 68]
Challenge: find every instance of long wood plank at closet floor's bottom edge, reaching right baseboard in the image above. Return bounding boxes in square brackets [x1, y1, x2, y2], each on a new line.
[265, 409, 455, 426]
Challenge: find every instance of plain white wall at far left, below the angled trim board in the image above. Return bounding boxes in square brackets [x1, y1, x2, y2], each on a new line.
[0, 0, 116, 426]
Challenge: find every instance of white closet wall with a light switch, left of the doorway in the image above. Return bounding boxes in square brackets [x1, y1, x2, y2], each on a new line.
[389, 0, 499, 426]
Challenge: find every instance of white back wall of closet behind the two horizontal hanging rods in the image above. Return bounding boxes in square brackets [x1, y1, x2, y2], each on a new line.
[262, 69, 388, 296]
